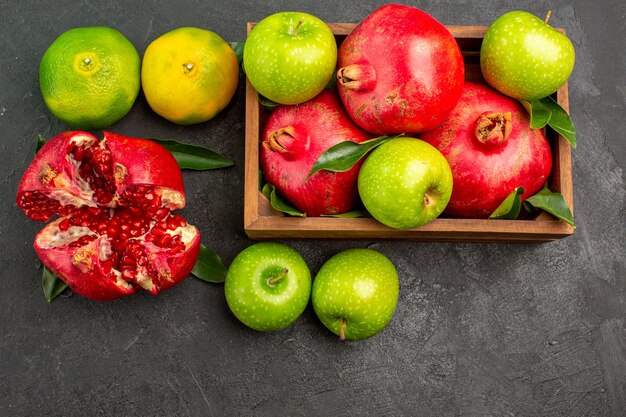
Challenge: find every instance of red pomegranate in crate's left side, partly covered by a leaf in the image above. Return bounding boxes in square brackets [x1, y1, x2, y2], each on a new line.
[261, 89, 371, 216]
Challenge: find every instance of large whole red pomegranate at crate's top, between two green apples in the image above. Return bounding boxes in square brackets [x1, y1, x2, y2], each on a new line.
[337, 4, 465, 135]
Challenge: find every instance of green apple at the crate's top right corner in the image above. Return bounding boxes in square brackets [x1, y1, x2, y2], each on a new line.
[480, 11, 575, 101]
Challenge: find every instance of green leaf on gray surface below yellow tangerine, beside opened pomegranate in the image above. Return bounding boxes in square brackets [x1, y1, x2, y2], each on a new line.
[146, 138, 233, 171]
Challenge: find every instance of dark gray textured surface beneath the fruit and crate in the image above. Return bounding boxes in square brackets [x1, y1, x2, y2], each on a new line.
[0, 0, 626, 416]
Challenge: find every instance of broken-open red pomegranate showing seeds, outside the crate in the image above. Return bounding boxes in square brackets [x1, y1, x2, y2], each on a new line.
[17, 132, 200, 300]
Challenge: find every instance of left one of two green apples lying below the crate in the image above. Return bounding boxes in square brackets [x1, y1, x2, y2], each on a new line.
[224, 242, 311, 331]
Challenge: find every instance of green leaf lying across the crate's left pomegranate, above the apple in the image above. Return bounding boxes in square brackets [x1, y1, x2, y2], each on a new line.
[306, 136, 398, 180]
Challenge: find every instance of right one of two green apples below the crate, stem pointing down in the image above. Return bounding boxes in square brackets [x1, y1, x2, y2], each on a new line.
[311, 249, 400, 340]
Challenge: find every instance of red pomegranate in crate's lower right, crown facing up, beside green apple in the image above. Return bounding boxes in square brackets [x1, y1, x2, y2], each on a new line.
[420, 82, 552, 218]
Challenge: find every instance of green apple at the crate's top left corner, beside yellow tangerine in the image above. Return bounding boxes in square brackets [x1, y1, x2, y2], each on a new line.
[243, 12, 337, 104]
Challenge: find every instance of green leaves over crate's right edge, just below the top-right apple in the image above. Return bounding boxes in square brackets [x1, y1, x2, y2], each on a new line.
[524, 97, 576, 148]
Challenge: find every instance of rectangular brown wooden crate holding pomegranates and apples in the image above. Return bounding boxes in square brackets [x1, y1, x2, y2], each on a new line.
[244, 23, 574, 243]
